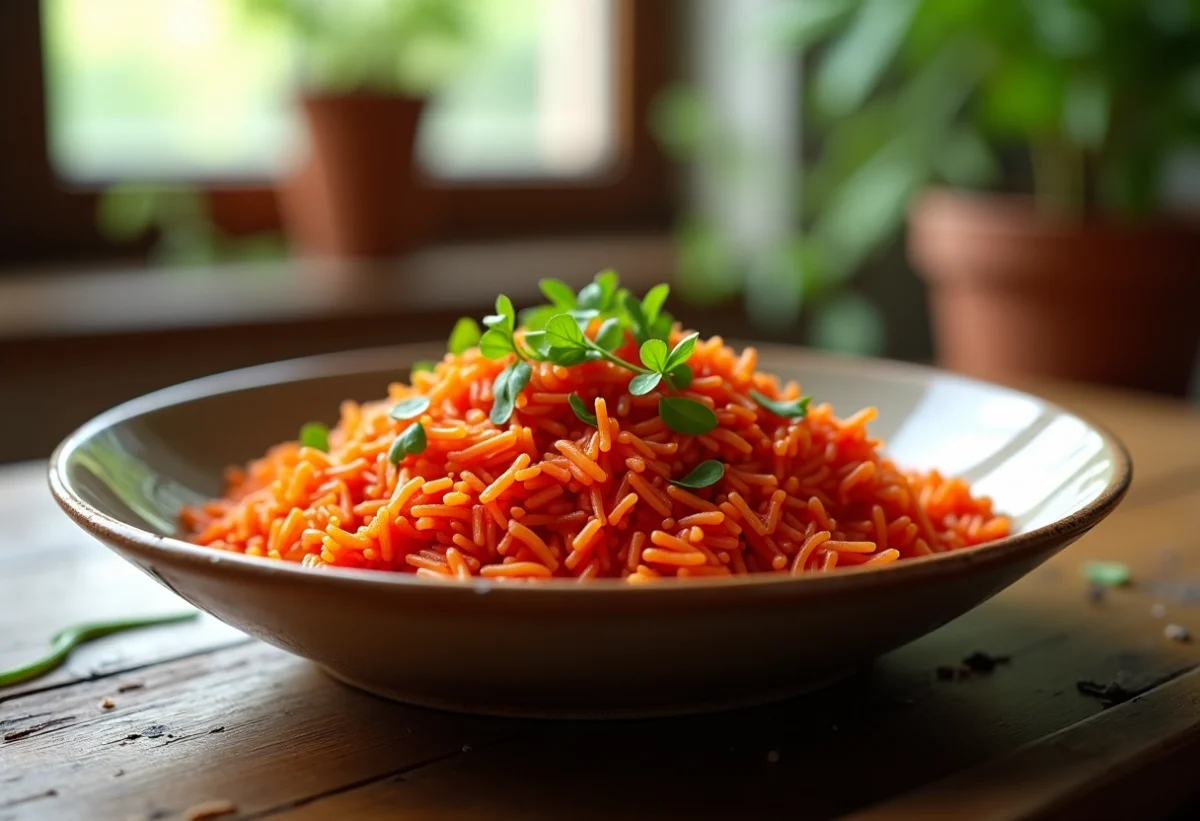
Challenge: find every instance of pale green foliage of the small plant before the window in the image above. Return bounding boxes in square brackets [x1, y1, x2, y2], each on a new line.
[248, 0, 473, 97]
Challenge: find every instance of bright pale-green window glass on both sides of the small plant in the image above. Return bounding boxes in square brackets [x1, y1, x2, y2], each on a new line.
[42, 0, 616, 182]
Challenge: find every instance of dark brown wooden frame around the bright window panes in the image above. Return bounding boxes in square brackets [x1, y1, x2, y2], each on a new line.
[0, 0, 679, 264]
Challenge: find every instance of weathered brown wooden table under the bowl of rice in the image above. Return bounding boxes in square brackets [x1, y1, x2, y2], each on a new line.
[0, 385, 1200, 821]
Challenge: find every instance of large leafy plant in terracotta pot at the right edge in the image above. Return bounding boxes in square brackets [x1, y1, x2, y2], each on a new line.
[781, 0, 1200, 394]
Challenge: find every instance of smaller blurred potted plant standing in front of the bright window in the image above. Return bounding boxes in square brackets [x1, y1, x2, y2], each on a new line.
[254, 0, 469, 257]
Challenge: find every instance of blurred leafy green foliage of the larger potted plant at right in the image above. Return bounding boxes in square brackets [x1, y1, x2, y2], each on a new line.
[650, 0, 1200, 353]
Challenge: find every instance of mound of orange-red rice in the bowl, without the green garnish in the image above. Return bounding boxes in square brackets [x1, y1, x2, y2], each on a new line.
[182, 326, 1009, 583]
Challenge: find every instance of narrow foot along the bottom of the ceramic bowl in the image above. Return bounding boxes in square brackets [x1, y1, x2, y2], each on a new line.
[320, 665, 869, 721]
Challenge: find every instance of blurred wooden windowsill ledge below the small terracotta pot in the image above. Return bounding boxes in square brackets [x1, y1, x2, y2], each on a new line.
[0, 233, 673, 340]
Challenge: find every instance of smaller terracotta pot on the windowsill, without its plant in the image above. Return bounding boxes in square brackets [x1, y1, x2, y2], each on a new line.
[280, 94, 442, 257]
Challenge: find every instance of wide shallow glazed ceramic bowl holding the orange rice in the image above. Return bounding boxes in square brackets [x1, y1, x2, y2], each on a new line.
[50, 346, 1130, 717]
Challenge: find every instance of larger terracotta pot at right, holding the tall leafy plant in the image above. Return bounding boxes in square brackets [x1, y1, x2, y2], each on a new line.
[908, 190, 1200, 395]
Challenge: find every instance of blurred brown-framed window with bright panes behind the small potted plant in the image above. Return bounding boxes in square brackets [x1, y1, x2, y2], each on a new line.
[0, 0, 678, 264]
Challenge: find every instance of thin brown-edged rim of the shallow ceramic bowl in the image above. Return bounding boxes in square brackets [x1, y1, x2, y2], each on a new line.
[48, 341, 1133, 598]
